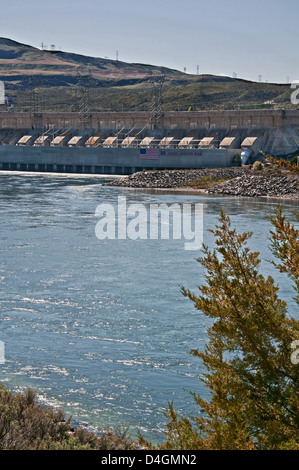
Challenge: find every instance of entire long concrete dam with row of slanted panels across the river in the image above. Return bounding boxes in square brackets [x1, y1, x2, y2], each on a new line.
[0, 110, 299, 174]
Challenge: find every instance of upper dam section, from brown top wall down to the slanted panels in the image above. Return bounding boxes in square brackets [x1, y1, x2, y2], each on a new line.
[0, 110, 299, 155]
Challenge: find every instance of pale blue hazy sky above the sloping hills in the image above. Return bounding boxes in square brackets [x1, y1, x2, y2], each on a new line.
[0, 0, 299, 83]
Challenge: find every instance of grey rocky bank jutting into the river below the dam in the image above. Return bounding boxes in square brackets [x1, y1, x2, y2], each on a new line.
[107, 167, 299, 199]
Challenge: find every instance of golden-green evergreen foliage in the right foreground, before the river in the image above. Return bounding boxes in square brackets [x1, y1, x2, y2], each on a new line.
[143, 208, 299, 450]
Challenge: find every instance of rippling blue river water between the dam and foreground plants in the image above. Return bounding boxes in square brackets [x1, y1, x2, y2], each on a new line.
[0, 173, 298, 442]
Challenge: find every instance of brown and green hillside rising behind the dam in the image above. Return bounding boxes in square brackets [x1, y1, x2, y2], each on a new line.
[0, 38, 294, 112]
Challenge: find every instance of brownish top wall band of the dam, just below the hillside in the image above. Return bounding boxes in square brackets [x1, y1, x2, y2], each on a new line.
[0, 110, 299, 132]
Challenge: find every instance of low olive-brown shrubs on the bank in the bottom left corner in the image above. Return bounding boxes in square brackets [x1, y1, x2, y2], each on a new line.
[0, 384, 134, 450]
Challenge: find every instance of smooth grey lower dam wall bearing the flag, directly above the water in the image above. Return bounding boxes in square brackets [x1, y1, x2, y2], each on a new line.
[0, 145, 235, 175]
